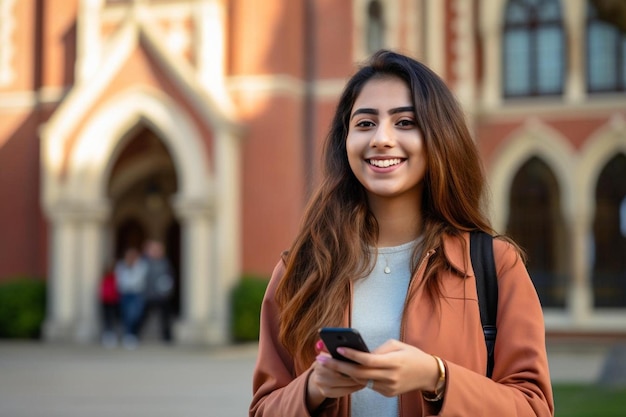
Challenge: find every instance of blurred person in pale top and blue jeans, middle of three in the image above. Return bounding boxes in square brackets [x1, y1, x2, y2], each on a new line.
[115, 247, 148, 349]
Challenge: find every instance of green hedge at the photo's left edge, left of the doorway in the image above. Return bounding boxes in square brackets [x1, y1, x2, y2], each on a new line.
[0, 277, 46, 339]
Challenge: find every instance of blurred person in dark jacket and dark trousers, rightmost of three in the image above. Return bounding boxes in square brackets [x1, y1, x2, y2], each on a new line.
[143, 240, 174, 342]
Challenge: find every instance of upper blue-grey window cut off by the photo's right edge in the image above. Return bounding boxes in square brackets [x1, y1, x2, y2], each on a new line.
[587, 1, 626, 93]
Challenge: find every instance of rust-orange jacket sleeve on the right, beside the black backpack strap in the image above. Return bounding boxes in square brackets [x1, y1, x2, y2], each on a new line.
[428, 239, 554, 417]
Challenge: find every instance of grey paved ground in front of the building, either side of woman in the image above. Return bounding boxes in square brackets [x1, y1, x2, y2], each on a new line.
[0, 341, 608, 417]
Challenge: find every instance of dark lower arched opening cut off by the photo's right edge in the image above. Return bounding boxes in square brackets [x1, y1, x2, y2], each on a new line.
[593, 154, 626, 308]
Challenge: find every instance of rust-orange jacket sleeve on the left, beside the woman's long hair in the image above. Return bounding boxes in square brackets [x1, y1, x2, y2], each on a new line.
[249, 261, 332, 417]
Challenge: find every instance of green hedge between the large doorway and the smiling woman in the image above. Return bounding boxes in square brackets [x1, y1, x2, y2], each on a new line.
[231, 276, 269, 342]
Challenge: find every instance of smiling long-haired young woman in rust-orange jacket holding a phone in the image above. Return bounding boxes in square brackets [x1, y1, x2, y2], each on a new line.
[250, 51, 554, 417]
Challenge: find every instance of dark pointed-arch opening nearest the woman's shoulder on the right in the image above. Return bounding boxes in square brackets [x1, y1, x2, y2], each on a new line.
[506, 157, 570, 308]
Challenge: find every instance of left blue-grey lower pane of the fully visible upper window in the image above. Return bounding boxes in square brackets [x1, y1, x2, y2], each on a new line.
[504, 30, 531, 95]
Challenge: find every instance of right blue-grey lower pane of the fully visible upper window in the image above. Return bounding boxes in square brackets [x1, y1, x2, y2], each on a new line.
[537, 27, 563, 93]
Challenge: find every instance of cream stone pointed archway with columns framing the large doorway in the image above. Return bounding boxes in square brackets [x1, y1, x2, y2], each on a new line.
[44, 88, 239, 344]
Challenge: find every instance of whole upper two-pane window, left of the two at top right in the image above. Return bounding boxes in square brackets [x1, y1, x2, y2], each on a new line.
[502, 0, 565, 97]
